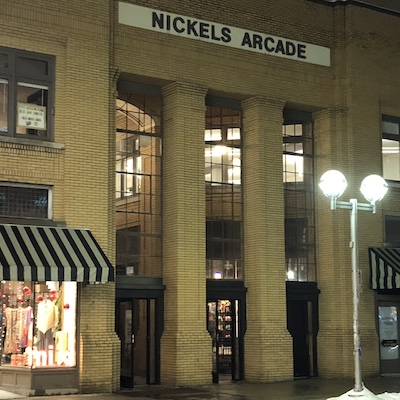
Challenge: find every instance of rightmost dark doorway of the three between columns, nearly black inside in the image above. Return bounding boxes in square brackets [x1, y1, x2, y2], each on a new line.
[286, 282, 319, 378]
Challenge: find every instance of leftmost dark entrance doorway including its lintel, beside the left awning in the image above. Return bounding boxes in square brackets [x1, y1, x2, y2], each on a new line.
[115, 276, 164, 388]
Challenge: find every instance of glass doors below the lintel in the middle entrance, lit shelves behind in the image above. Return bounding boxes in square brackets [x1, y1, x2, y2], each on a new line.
[207, 300, 243, 383]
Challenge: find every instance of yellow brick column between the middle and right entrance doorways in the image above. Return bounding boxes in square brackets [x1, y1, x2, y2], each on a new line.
[242, 97, 293, 382]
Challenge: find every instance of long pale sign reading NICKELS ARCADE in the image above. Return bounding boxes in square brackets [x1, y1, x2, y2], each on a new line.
[118, 2, 331, 67]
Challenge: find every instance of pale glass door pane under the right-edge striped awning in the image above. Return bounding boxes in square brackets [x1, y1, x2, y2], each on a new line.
[378, 302, 400, 375]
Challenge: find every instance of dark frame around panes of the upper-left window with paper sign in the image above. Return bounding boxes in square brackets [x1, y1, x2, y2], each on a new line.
[0, 47, 55, 141]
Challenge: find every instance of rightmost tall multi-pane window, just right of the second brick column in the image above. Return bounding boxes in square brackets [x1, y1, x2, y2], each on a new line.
[282, 111, 316, 281]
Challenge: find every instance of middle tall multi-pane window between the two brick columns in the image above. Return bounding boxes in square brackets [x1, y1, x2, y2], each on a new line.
[204, 101, 243, 279]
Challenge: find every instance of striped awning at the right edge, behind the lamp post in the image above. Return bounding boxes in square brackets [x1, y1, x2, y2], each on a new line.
[369, 247, 400, 289]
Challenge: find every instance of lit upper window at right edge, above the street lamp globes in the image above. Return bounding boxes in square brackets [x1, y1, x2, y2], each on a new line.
[382, 115, 400, 181]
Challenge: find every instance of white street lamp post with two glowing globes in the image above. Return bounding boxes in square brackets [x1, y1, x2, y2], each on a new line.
[319, 170, 388, 392]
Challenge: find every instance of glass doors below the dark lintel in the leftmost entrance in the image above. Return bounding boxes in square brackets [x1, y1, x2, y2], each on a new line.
[116, 299, 159, 388]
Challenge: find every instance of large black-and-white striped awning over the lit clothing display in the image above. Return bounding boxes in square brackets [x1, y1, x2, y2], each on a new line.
[0, 225, 114, 283]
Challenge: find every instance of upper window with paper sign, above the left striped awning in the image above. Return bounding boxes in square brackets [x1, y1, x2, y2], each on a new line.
[0, 47, 54, 140]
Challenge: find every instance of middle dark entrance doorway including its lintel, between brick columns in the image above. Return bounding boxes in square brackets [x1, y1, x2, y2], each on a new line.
[207, 280, 246, 383]
